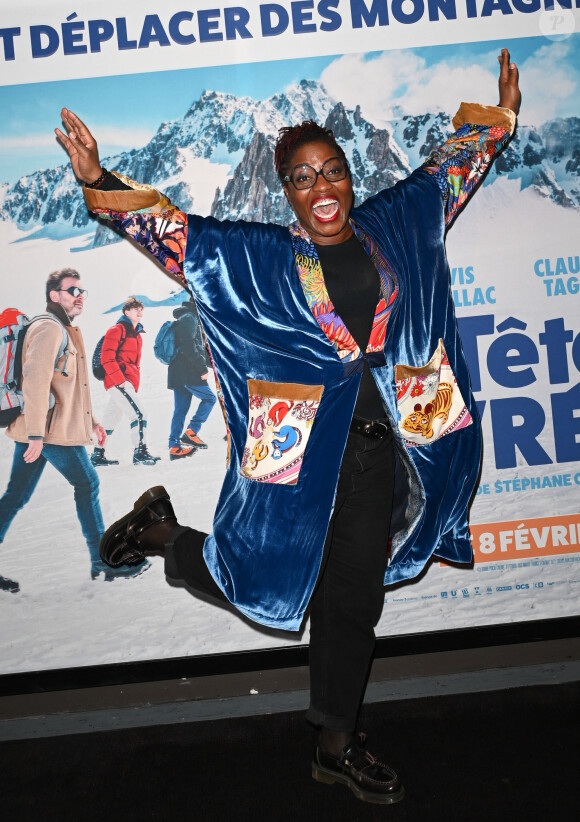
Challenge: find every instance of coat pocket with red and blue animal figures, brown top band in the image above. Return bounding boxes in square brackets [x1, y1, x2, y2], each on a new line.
[240, 380, 324, 485]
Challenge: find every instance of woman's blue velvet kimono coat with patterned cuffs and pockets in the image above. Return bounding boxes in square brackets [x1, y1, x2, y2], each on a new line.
[87, 107, 513, 630]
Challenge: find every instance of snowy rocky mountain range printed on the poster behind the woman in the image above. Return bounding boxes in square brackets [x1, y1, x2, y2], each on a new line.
[0, 80, 580, 246]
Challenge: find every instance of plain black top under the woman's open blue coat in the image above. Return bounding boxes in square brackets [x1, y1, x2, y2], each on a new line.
[316, 235, 385, 420]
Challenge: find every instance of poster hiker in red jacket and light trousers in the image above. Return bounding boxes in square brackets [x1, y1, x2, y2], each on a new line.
[91, 297, 160, 467]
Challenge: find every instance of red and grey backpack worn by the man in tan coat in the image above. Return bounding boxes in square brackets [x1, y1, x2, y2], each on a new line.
[0, 308, 69, 428]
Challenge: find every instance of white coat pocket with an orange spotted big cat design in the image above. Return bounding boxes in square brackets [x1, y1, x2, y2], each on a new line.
[395, 340, 472, 445]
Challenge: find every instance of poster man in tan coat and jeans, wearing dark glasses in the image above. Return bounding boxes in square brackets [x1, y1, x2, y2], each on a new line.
[0, 268, 150, 593]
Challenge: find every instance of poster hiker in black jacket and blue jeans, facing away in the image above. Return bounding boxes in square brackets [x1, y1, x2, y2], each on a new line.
[167, 300, 216, 460]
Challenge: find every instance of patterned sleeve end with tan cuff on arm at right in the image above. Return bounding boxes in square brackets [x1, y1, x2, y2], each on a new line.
[423, 103, 516, 226]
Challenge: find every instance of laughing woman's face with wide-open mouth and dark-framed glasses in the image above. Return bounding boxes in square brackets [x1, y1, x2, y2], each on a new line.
[284, 142, 353, 245]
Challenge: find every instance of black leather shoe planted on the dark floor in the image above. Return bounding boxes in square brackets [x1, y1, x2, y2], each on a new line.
[312, 734, 405, 805]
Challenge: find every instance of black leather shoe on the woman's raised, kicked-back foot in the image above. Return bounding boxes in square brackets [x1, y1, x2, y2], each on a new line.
[99, 485, 177, 568]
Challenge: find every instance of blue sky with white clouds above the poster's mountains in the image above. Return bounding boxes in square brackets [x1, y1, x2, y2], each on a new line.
[0, 34, 580, 182]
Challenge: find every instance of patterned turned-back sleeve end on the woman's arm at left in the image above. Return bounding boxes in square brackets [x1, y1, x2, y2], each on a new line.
[83, 175, 187, 286]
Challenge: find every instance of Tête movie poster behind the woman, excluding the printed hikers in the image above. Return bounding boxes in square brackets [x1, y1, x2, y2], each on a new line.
[0, 0, 580, 673]
